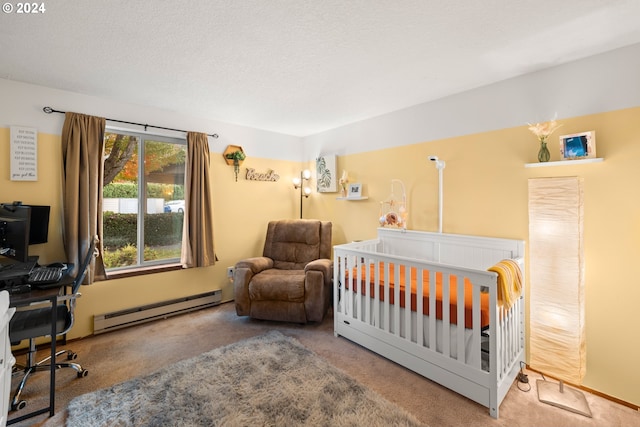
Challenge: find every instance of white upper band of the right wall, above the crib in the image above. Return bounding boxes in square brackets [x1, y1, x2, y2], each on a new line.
[304, 44, 640, 160]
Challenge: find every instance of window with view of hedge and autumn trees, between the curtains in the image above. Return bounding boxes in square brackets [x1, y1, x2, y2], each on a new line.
[102, 129, 187, 271]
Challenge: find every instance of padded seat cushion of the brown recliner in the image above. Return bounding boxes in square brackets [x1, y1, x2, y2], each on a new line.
[249, 268, 305, 302]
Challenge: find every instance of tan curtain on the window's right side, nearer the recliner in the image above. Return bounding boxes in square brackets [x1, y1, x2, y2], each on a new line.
[181, 132, 216, 268]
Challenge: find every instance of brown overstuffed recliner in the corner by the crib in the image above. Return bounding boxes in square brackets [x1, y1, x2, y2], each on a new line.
[233, 219, 333, 323]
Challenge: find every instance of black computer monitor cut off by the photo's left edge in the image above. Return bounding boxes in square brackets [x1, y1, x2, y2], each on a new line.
[0, 204, 31, 262]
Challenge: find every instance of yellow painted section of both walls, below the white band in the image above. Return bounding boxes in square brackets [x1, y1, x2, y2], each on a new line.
[0, 108, 640, 405]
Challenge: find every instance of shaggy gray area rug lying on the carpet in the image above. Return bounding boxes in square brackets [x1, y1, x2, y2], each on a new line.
[67, 331, 422, 427]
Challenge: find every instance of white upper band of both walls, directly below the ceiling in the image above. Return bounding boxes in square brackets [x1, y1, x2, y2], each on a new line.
[0, 44, 640, 161]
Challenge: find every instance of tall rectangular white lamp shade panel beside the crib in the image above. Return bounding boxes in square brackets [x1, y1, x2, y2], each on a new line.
[529, 177, 586, 384]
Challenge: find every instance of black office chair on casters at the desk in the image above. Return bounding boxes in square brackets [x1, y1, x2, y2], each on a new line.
[9, 240, 95, 411]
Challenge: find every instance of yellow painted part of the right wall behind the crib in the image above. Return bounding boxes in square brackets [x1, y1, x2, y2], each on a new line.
[311, 108, 640, 405]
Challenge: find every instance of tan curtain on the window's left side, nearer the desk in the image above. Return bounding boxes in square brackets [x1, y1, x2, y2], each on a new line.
[62, 113, 106, 284]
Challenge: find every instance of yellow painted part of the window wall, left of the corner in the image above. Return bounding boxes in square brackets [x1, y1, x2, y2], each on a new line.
[0, 128, 302, 339]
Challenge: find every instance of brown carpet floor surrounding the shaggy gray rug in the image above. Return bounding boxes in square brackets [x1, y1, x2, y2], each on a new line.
[9, 303, 640, 427]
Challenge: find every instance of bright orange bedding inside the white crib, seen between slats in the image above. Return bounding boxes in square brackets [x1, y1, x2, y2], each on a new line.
[347, 263, 489, 328]
